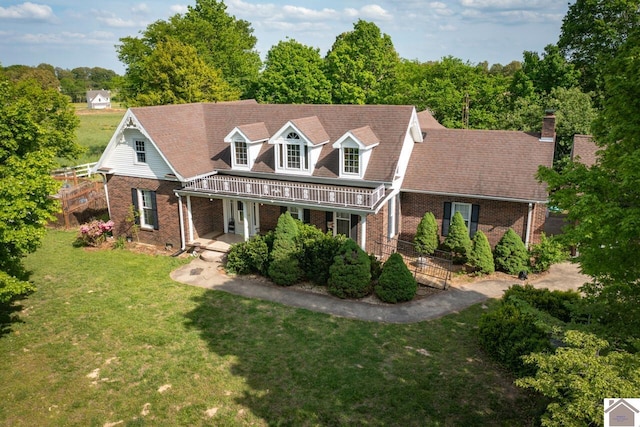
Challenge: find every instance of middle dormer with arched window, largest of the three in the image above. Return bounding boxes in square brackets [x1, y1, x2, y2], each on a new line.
[269, 116, 329, 175]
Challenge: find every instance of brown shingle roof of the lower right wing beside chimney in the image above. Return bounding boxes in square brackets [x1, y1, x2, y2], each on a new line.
[402, 129, 554, 201]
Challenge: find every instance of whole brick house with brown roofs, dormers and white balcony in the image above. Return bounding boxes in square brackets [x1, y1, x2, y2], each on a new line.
[95, 101, 553, 252]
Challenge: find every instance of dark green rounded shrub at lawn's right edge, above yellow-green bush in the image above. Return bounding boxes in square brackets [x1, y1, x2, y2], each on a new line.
[478, 301, 551, 376]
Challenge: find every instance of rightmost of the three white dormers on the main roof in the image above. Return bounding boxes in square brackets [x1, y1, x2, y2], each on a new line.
[333, 126, 380, 179]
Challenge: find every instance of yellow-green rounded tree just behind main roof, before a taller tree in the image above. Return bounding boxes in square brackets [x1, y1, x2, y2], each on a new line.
[130, 39, 239, 105]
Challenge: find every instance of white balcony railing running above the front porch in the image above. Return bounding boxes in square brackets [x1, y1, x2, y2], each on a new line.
[183, 175, 385, 209]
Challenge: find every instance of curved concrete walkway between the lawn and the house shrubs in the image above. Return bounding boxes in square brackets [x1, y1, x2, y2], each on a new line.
[171, 258, 589, 323]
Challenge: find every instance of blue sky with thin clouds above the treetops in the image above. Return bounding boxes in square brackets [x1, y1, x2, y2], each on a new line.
[0, 0, 574, 74]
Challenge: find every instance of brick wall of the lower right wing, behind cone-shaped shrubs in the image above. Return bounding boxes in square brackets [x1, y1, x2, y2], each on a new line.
[400, 193, 546, 246]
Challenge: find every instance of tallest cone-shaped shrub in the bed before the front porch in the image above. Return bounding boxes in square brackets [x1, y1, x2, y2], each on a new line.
[267, 212, 303, 286]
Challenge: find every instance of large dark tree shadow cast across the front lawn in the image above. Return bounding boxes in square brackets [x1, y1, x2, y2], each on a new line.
[186, 290, 537, 426]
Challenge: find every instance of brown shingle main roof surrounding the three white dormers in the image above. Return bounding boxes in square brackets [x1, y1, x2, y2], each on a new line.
[131, 102, 414, 182]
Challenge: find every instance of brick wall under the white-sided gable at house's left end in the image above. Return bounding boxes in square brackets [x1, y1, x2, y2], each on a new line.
[107, 175, 186, 248]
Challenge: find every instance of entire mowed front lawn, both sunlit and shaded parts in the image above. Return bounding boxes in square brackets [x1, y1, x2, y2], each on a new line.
[0, 231, 540, 426]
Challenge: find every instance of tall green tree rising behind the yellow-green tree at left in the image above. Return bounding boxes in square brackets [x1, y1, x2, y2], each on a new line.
[117, 0, 260, 99]
